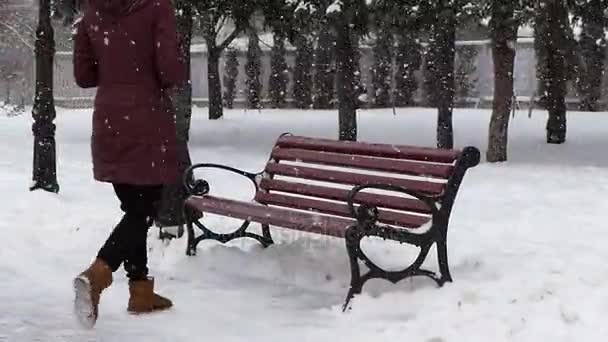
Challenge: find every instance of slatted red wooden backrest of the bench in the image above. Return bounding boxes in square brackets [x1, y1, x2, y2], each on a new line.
[255, 135, 478, 228]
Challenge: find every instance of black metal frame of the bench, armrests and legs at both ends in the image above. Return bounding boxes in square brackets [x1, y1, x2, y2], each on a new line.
[183, 134, 480, 311]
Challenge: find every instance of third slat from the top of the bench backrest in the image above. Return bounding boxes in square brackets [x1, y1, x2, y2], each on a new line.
[266, 163, 445, 195]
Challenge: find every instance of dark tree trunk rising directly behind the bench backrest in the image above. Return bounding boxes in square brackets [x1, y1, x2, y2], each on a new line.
[336, 17, 357, 141]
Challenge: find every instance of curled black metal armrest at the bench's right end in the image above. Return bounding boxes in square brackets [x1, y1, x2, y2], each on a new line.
[347, 184, 439, 224]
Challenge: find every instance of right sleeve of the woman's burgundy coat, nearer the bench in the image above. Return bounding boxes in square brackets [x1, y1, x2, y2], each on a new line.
[154, 0, 187, 88]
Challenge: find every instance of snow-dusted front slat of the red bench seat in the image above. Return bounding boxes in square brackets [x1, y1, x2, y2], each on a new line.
[186, 196, 355, 238]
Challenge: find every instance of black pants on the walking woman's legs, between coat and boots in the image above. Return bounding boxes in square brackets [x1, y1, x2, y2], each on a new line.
[97, 184, 162, 280]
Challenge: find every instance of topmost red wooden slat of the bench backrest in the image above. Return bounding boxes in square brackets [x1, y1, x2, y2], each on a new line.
[277, 136, 460, 164]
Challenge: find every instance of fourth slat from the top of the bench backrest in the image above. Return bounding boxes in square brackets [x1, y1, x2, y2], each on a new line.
[260, 179, 431, 214]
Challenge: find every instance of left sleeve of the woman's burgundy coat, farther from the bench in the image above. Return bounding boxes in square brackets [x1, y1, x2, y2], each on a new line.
[72, 19, 98, 88]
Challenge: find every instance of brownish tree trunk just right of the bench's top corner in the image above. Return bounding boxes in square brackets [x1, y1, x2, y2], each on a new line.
[486, 0, 518, 162]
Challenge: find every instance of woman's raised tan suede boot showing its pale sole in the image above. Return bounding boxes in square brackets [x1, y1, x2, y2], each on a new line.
[74, 259, 112, 328]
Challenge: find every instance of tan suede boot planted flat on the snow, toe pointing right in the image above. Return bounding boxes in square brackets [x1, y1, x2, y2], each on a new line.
[127, 278, 173, 314]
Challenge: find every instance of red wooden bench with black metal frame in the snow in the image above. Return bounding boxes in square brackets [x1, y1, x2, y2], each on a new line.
[184, 135, 480, 309]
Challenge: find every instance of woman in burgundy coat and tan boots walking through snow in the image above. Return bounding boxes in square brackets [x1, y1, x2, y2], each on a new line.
[74, 0, 186, 326]
